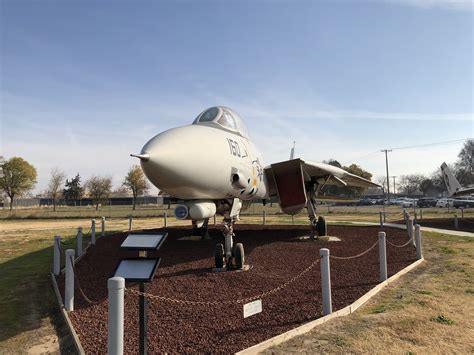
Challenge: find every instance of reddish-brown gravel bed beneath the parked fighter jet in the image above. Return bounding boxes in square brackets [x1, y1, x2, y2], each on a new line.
[59, 225, 415, 354]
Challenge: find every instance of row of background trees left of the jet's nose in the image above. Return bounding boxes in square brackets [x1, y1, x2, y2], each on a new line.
[0, 161, 149, 211]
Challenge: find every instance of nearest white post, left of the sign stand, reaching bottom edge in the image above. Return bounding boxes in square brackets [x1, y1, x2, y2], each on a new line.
[107, 277, 125, 355]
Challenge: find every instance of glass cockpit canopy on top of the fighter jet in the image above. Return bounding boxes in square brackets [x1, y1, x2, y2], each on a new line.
[193, 106, 249, 138]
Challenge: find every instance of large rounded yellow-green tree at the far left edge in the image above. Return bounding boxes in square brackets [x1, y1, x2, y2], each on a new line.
[0, 157, 37, 211]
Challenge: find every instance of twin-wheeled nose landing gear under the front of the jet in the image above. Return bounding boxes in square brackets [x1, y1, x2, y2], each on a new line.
[214, 217, 245, 270]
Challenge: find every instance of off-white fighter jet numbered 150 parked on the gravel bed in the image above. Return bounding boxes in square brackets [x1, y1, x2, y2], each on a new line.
[131, 106, 379, 269]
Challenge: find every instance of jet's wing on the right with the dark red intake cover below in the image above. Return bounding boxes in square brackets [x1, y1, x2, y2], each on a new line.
[265, 159, 380, 214]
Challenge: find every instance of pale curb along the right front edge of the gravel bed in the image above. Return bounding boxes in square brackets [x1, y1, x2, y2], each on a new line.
[236, 258, 425, 355]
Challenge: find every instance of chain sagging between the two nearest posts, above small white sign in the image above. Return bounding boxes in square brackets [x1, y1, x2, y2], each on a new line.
[125, 259, 319, 306]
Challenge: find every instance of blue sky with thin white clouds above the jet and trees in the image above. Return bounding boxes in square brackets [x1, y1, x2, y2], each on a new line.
[0, 0, 474, 195]
